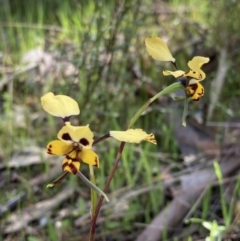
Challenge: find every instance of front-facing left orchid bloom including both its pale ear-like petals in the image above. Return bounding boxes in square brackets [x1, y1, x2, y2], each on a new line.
[41, 92, 156, 190]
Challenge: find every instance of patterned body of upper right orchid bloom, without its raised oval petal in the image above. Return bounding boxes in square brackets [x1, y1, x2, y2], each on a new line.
[163, 56, 210, 101]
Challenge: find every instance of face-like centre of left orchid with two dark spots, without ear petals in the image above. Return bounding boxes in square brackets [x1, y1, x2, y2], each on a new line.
[47, 122, 99, 174]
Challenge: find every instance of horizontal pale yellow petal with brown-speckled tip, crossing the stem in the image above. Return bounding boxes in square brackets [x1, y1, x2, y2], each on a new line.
[110, 129, 157, 144]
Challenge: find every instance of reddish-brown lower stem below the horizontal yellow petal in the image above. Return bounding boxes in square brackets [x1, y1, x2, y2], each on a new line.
[89, 142, 125, 241]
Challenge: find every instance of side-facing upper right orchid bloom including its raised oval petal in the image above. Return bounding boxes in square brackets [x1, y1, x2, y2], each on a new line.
[145, 37, 209, 101]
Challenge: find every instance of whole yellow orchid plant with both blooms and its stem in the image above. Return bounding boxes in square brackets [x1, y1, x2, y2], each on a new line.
[41, 37, 209, 240]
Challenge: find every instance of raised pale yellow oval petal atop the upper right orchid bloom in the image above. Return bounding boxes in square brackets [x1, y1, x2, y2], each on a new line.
[145, 37, 175, 63]
